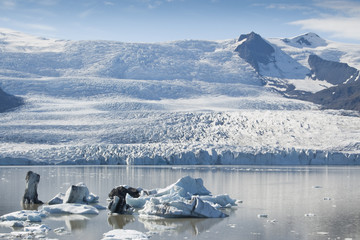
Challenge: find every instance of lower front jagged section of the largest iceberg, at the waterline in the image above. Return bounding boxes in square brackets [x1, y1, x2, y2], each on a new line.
[139, 196, 227, 218]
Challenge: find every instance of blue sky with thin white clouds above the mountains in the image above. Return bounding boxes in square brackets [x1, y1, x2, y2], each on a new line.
[0, 0, 360, 43]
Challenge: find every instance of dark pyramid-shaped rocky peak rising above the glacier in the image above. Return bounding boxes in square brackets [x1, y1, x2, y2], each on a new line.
[235, 32, 275, 72]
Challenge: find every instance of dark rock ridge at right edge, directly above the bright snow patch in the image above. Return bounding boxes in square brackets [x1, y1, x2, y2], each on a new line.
[308, 54, 359, 85]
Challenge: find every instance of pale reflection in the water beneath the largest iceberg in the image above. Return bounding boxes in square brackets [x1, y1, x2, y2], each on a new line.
[139, 218, 223, 236]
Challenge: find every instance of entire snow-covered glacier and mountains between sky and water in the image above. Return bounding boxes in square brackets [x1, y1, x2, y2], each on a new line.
[0, 30, 360, 164]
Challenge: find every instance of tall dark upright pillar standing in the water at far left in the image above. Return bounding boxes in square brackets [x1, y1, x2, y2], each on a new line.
[22, 171, 43, 204]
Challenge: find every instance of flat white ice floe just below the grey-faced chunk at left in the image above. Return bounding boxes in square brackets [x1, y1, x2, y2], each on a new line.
[42, 203, 99, 214]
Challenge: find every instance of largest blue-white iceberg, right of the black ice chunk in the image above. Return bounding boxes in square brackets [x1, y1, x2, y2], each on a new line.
[126, 176, 236, 218]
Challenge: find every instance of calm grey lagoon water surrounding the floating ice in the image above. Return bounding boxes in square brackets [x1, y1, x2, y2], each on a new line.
[0, 166, 360, 240]
